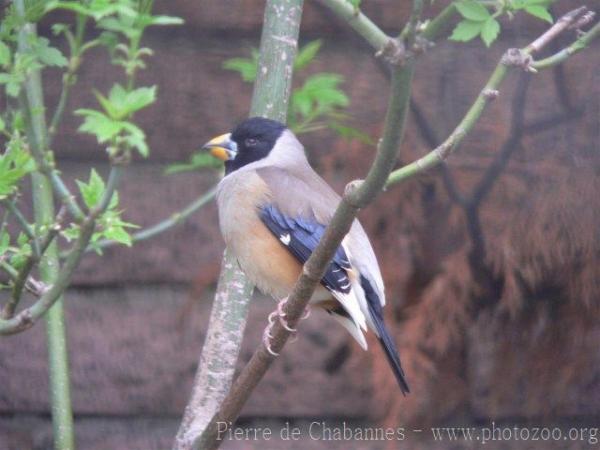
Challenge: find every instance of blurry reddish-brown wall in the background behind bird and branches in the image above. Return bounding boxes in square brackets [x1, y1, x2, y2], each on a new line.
[0, 0, 600, 450]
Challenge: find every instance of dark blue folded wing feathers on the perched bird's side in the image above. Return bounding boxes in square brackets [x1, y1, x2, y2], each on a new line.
[259, 204, 351, 294]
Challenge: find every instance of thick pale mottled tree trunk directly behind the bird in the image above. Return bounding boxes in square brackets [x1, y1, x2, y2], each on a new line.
[173, 0, 303, 450]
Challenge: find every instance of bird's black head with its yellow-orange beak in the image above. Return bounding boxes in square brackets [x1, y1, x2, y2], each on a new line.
[204, 117, 286, 174]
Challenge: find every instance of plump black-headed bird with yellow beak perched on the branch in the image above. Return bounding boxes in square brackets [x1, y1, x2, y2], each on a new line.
[202, 117, 410, 395]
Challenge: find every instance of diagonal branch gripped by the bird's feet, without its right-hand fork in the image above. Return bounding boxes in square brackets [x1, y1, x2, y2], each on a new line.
[197, 0, 421, 449]
